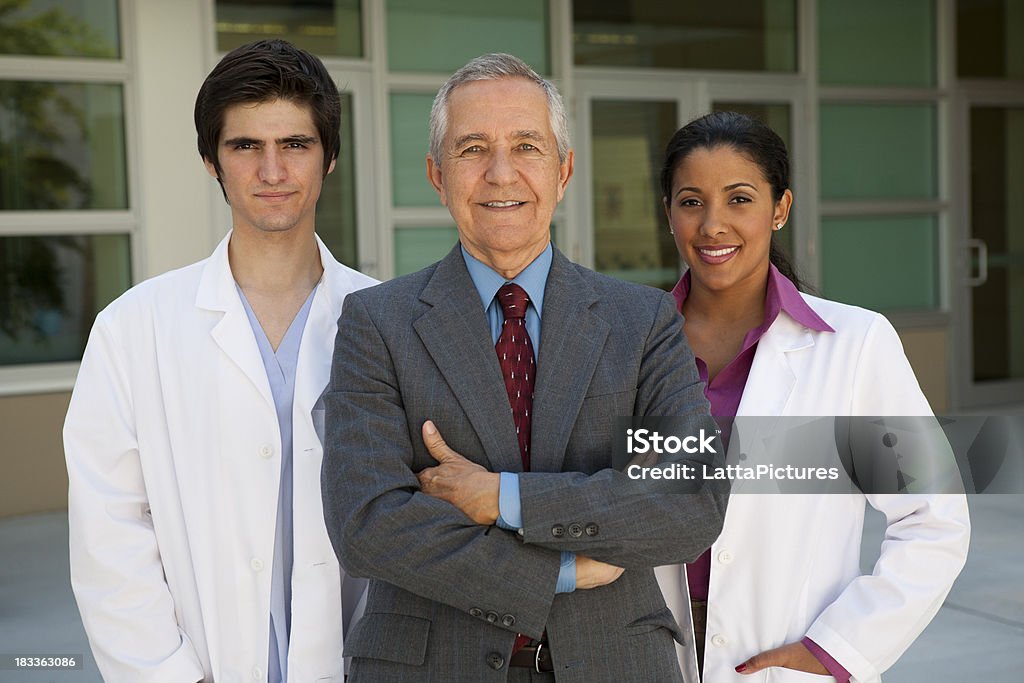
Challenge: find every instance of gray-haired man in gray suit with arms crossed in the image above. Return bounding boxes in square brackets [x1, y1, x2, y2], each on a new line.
[322, 54, 727, 683]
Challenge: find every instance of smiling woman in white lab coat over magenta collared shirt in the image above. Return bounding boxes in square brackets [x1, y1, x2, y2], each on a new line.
[658, 113, 969, 683]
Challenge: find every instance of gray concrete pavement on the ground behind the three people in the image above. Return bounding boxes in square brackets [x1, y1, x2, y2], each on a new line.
[0, 495, 1024, 683]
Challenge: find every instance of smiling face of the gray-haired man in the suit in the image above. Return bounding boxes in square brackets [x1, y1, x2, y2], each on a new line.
[427, 78, 572, 278]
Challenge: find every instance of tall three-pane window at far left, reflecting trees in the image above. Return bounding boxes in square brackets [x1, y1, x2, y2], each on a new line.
[0, 0, 136, 368]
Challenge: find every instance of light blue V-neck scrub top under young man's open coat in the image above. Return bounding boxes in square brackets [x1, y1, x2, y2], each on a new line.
[236, 285, 317, 683]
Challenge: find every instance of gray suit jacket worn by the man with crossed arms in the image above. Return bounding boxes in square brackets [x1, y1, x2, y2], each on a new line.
[322, 245, 726, 683]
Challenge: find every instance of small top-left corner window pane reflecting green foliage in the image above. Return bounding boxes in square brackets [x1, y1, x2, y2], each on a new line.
[0, 0, 121, 59]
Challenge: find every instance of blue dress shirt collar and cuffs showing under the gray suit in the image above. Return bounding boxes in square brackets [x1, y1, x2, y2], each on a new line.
[462, 243, 575, 593]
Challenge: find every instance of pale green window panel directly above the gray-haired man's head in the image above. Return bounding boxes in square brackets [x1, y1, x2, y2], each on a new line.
[387, 0, 551, 75]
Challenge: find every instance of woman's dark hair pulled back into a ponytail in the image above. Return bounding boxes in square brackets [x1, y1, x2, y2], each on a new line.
[662, 112, 806, 291]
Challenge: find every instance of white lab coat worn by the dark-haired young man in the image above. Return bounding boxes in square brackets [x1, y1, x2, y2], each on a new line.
[63, 236, 375, 683]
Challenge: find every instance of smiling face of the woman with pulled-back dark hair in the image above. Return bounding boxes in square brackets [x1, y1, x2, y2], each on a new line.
[666, 146, 793, 292]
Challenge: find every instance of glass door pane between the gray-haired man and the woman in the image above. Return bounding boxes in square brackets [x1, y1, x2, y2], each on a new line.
[591, 100, 679, 289]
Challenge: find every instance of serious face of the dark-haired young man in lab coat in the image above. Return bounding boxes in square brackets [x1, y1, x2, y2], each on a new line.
[206, 99, 334, 237]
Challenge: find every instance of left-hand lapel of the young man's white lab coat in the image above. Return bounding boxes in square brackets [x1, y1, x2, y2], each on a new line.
[196, 229, 273, 407]
